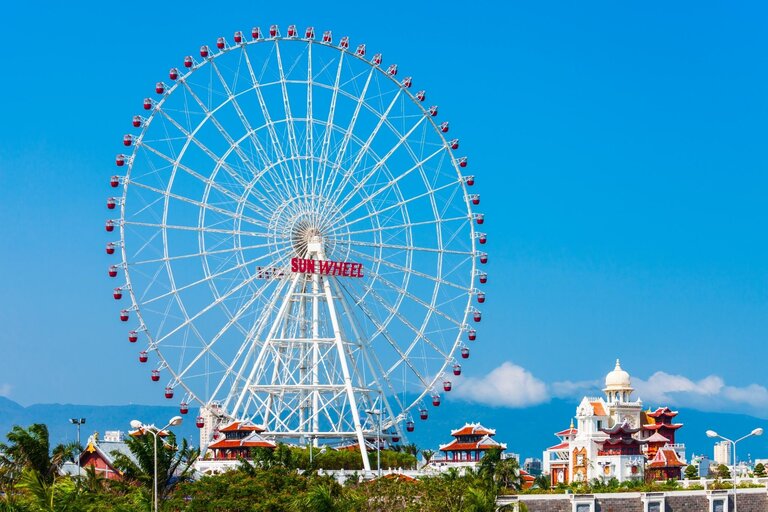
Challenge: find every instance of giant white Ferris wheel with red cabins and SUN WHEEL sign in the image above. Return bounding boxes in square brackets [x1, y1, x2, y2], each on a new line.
[106, 25, 488, 469]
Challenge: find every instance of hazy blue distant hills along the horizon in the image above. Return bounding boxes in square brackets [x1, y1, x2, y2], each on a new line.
[0, 397, 768, 459]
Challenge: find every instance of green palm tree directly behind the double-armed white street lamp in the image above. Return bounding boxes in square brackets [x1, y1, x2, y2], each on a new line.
[112, 432, 200, 500]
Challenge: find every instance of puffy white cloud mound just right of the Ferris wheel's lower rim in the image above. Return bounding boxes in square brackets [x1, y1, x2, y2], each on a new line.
[456, 361, 549, 407]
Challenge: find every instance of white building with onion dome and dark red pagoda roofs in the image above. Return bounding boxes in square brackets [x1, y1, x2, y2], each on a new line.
[543, 360, 685, 486]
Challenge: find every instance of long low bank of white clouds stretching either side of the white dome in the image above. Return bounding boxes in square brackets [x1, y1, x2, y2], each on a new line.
[455, 361, 768, 418]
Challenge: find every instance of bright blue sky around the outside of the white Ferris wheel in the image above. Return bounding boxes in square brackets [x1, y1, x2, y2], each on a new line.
[0, 1, 768, 436]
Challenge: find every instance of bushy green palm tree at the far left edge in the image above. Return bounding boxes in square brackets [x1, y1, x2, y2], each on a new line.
[0, 423, 79, 485]
